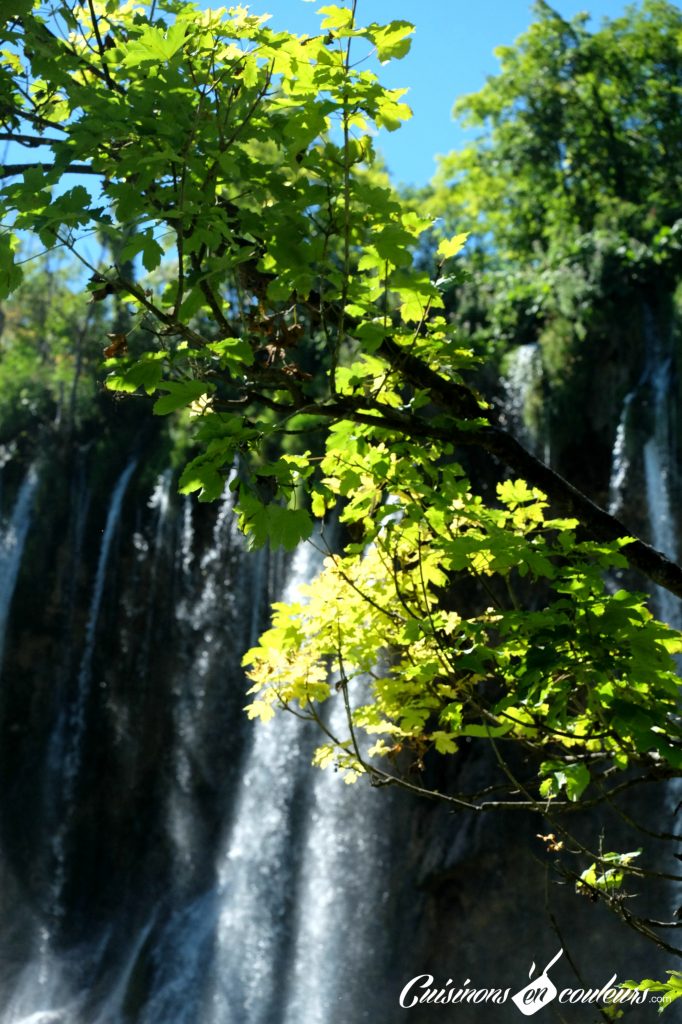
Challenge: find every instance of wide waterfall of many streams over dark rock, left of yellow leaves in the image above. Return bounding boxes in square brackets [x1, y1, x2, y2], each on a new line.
[0, 452, 390, 1024]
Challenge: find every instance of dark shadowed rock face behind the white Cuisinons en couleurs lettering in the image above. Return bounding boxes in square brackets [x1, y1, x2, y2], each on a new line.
[387, 737, 678, 1024]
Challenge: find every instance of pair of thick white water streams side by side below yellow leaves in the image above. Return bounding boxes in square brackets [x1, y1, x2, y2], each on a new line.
[142, 536, 389, 1024]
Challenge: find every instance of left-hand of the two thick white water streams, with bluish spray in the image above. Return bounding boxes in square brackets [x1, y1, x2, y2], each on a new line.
[142, 540, 327, 1024]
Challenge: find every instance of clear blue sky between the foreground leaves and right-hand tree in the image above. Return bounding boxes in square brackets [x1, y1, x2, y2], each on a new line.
[249, 0, 667, 185]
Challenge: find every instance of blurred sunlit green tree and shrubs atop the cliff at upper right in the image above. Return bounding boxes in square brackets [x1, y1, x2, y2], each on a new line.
[429, 0, 682, 352]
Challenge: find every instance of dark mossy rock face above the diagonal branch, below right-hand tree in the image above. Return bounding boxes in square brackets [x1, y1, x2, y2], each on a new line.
[496, 290, 679, 509]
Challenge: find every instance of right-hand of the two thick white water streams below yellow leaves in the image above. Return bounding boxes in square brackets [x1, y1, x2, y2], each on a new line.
[283, 693, 391, 1024]
